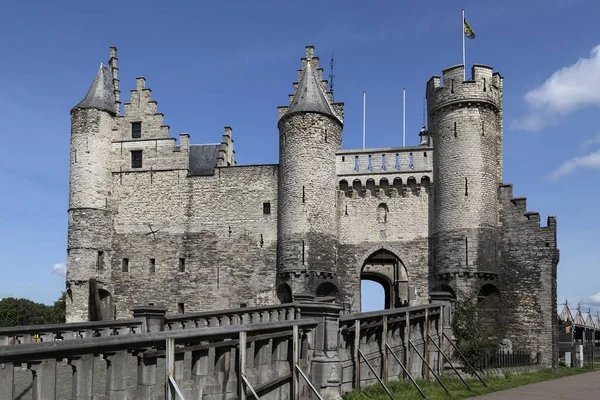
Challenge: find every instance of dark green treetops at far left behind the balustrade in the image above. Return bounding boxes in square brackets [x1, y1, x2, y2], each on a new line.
[0, 292, 66, 327]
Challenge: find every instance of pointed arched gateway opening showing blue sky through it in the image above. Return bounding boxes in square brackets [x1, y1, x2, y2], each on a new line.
[360, 249, 409, 311]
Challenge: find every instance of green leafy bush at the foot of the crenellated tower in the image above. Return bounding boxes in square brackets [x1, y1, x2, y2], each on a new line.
[452, 293, 504, 367]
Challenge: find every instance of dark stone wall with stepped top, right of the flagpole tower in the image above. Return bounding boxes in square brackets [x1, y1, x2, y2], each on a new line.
[499, 185, 559, 365]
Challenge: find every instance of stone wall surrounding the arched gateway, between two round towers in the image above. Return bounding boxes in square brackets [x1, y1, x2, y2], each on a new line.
[337, 179, 431, 312]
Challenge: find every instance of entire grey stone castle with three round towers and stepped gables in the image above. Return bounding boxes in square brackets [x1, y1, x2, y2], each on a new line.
[67, 46, 559, 352]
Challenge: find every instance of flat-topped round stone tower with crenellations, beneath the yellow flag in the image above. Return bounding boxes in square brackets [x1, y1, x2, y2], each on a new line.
[426, 65, 502, 291]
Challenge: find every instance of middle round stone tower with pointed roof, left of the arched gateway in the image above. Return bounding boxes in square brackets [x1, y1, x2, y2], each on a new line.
[277, 47, 343, 302]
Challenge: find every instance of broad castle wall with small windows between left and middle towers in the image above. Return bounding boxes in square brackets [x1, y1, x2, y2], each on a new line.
[111, 166, 277, 316]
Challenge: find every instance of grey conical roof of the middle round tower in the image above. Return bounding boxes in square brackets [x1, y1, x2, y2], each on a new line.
[286, 60, 339, 121]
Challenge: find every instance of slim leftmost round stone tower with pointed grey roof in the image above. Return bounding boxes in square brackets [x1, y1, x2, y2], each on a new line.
[67, 53, 118, 322]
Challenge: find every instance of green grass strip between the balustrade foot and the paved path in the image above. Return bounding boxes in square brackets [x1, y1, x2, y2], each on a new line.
[344, 367, 591, 400]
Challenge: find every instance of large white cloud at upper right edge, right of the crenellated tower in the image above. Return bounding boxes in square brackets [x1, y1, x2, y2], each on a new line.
[513, 45, 600, 132]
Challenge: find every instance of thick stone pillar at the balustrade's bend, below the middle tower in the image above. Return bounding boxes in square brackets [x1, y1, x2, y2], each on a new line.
[300, 302, 342, 400]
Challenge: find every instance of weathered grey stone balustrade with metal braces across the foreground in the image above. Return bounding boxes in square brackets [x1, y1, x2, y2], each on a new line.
[0, 299, 443, 400]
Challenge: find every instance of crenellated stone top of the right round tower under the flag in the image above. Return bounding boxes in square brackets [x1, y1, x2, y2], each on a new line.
[426, 64, 503, 114]
